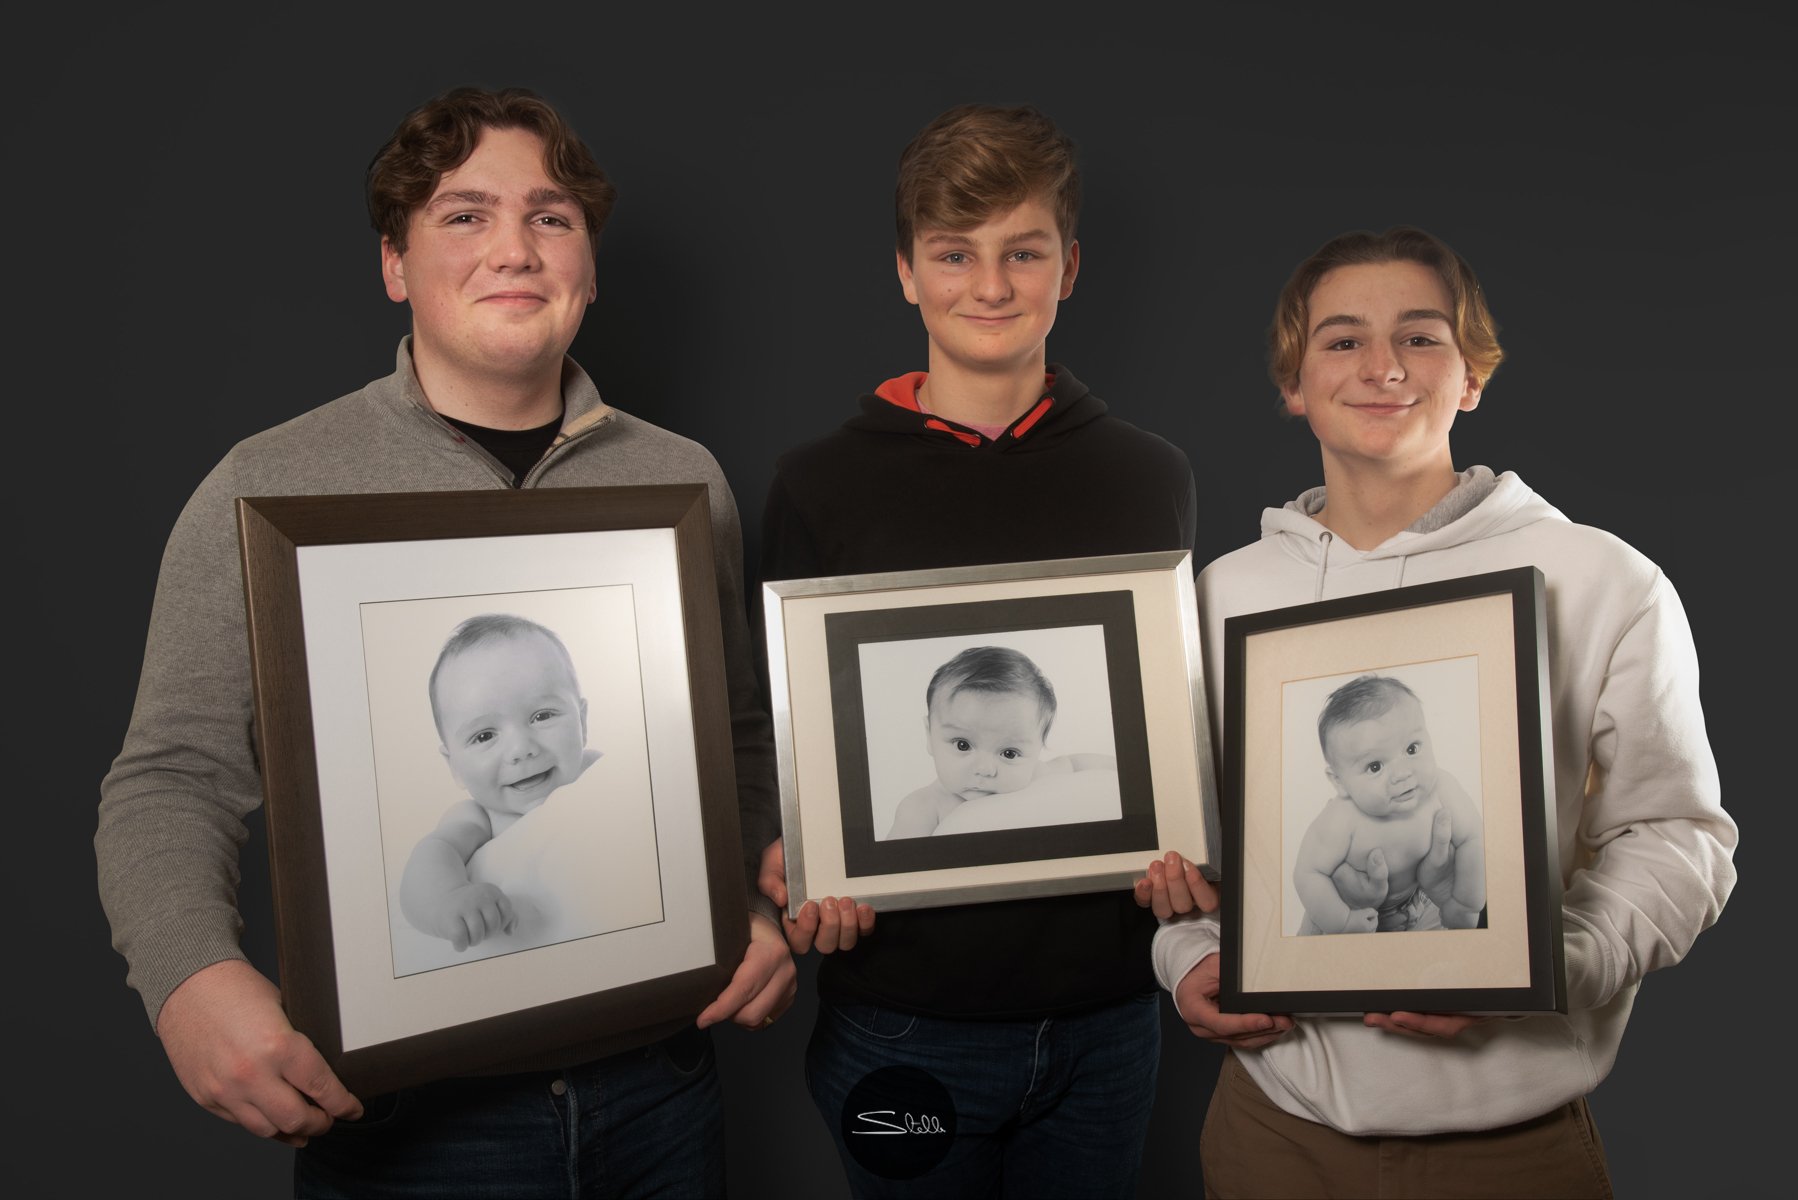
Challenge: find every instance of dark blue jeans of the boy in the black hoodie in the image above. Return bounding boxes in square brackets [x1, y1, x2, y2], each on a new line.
[806, 993, 1162, 1200]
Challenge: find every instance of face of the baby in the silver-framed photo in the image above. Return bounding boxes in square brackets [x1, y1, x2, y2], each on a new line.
[924, 689, 1043, 801]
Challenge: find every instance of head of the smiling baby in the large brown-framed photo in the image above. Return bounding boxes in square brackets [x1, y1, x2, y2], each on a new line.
[437, 633, 586, 813]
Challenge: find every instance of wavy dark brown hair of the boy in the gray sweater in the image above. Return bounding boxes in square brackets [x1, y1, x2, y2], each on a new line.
[367, 86, 619, 254]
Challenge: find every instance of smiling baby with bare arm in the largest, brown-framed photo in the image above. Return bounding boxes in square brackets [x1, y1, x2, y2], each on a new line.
[399, 613, 599, 950]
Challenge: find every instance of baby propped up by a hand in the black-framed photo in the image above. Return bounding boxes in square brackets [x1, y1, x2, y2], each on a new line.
[1293, 675, 1485, 934]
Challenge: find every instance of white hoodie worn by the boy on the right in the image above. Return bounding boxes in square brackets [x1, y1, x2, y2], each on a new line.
[1154, 468, 1735, 1135]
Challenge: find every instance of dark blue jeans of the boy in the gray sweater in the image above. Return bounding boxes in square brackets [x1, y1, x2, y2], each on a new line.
[293, 1029, 725, 1200]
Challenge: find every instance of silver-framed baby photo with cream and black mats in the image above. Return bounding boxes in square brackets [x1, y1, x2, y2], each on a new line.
[762, 551, 1221, 914]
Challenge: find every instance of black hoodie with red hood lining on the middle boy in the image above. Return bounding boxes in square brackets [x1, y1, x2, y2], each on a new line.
[762, 365, 1196, 1020]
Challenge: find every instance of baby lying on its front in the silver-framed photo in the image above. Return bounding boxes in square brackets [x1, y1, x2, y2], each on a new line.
[886, 646, 1117, 838]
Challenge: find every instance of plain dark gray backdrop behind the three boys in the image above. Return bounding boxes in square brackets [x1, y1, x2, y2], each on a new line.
[21, 4, 1793, 1196]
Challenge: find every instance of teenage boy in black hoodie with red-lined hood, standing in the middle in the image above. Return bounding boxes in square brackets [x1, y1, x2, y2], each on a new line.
[761, 104, 1196, 1196]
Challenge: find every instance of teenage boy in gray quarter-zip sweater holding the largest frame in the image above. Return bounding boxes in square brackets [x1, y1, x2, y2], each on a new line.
[95, 88, 795, 1195]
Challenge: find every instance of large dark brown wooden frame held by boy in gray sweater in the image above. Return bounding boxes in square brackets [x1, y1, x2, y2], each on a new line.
[237, 484, 748, 1096]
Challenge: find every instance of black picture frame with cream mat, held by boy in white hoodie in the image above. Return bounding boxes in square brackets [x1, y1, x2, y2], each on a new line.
[1219, 567, 1566, 1013]
